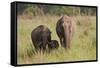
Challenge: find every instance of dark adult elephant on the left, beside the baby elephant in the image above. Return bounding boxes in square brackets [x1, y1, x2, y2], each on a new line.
[31, 25, 51, 52]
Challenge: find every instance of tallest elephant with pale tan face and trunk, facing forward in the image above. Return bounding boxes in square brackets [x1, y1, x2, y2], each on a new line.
[56, 15, 74, 48]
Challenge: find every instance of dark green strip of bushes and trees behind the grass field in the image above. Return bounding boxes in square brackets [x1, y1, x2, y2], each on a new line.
[17, 4, 96, 16]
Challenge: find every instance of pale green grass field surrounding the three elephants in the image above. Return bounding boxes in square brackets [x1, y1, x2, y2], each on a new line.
[17, 15, 96, 64]
